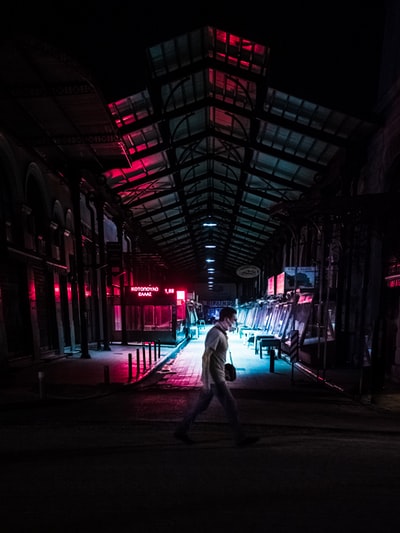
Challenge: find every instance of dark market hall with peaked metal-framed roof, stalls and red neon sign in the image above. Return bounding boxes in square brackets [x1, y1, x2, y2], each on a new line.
[0, 2, 400, 400]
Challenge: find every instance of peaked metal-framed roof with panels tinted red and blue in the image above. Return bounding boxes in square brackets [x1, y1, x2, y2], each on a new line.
[0, 27, 375, 282]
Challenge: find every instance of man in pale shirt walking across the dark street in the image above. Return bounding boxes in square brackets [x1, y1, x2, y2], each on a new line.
[174, 307, 259, 446]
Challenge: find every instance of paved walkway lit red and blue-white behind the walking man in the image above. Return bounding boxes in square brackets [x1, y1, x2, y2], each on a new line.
[0, 327, 292, 402]
